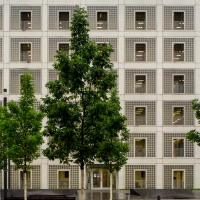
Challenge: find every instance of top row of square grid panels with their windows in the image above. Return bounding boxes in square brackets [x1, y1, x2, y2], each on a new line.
[0, 6, 194, 31]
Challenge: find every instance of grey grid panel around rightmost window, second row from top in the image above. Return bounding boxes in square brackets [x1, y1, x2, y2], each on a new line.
[164, 38, 194, 62]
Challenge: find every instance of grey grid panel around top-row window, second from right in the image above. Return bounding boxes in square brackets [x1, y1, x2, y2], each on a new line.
[125, 6, 156, 30]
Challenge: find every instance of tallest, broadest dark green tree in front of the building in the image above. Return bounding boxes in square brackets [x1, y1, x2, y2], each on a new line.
[41, 7, 127, 194]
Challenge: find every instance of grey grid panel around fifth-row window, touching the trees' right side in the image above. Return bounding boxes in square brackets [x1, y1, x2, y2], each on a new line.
[126, 133, 156, 157]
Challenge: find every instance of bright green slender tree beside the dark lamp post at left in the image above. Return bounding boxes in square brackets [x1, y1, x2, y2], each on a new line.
[0, 69, 44, 200]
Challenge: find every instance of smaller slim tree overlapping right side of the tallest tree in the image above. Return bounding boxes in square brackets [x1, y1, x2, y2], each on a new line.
[97, 88, 129, 200]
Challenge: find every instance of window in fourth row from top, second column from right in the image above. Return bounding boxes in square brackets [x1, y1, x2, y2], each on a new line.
[135, 107, 146, 126]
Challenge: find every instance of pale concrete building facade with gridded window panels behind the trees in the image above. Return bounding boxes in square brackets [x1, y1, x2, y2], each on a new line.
[0, 0, 200, 189]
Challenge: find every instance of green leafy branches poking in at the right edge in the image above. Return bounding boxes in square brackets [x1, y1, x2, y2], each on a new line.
[186, 99, 200, 146]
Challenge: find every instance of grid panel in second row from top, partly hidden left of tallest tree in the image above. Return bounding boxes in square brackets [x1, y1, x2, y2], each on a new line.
[49, 38, 70, 62]
